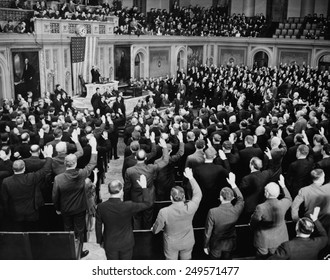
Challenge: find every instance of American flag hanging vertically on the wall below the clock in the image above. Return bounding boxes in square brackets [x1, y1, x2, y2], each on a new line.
[71, 36, 97, 94]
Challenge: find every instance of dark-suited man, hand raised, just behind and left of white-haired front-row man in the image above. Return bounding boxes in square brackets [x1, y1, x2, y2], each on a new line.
[239, 150, 274, 223]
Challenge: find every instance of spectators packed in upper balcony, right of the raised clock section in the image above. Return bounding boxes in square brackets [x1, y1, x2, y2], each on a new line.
[116, 6, 266, 37]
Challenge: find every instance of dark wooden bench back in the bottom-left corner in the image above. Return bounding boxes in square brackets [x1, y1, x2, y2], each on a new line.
[0, 232, 82, 260]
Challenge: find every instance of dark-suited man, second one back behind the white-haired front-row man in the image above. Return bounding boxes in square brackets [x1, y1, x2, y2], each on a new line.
[237, 135, 264, 181]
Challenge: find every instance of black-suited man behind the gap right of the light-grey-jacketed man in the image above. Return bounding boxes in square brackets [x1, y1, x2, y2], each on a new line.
[193, 148, 230, 227]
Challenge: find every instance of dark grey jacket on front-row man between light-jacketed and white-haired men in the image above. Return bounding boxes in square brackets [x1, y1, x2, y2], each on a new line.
[204, 188, 244, 258]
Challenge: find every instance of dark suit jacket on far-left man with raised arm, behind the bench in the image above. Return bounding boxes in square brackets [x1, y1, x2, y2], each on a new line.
[1, 158, 52, 222]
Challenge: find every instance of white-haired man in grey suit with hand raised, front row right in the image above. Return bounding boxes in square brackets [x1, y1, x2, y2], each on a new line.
[250, 176, 292, 259]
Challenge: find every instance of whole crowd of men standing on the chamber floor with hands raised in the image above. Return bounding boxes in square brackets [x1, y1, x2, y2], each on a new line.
[0, 61, 330, 259]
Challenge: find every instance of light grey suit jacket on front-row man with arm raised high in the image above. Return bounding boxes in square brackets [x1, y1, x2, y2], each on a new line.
[152, 178, 202, 253]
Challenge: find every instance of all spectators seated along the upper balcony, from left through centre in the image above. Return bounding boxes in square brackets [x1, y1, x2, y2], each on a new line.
[1, 0, 268, 37]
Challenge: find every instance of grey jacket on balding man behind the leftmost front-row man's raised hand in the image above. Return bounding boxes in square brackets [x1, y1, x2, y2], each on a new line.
[124, 148, 169, 202]
